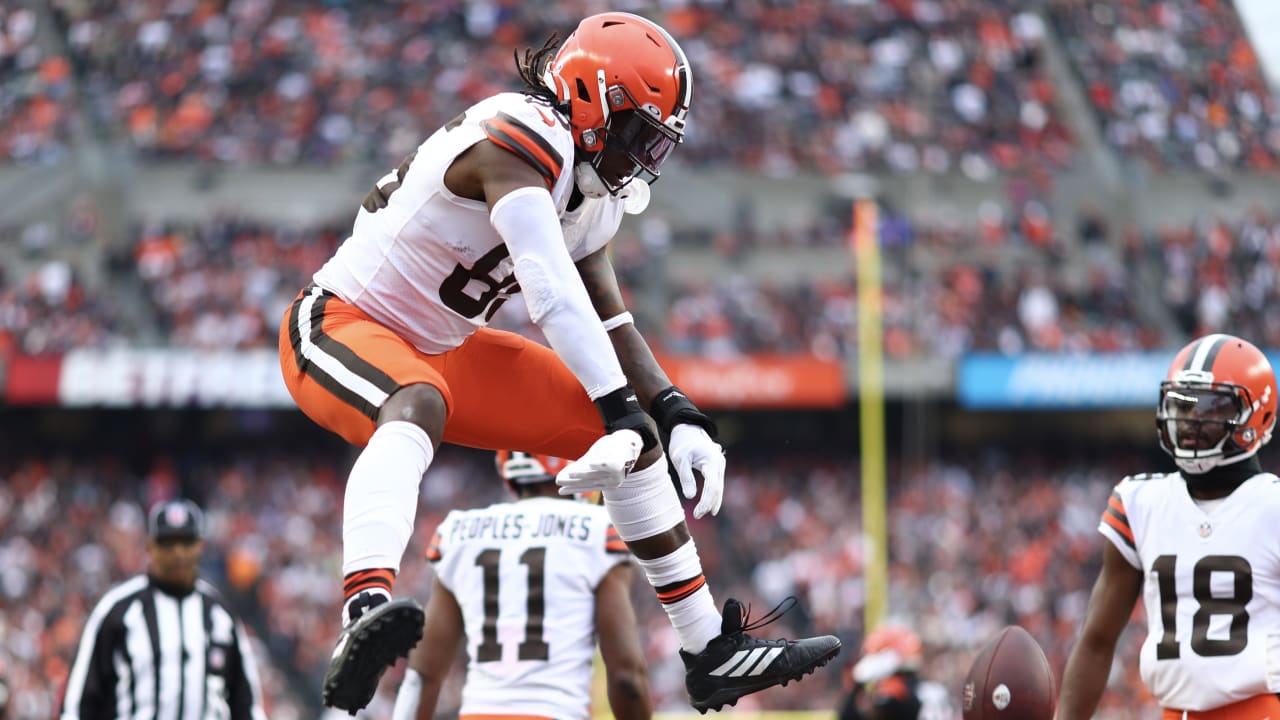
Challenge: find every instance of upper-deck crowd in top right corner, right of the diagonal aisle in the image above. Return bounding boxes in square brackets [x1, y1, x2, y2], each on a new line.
[1050, 0, 1280, 173]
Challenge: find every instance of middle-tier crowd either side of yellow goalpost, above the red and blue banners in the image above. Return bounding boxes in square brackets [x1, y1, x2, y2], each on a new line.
[658, 211, 1162, 357]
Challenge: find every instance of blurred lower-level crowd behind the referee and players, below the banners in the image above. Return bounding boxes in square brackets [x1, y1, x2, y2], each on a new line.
[0, 448, 1172, 720]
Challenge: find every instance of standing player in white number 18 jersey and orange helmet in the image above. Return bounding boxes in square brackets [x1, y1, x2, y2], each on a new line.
[1057, 334, 1280, 720]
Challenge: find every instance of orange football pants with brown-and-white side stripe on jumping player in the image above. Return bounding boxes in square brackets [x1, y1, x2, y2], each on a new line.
[280, 286, 604, 459]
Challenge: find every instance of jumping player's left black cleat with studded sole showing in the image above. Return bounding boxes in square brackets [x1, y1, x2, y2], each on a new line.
[323, 596, 425, 715]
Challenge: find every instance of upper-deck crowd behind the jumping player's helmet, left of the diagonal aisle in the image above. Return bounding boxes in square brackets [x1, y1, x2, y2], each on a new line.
[17, 0, 1071, 177]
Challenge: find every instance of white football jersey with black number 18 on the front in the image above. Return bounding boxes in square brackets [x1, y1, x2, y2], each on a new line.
[1098, 473, 1280, 711]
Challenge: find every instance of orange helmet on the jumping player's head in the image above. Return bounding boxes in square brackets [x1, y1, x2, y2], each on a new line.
[543, 13, 694, 195]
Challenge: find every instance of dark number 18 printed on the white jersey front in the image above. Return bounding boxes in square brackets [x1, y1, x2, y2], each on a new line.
[1151, 555, 1253, 660]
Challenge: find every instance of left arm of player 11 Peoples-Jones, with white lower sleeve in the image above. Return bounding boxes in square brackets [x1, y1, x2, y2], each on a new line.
[392, 578, 463, 720]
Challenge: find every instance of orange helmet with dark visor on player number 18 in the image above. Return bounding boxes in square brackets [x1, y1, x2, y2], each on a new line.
[1156, 334, 1276, 474]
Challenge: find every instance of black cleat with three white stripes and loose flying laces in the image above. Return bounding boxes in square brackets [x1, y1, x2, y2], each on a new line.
[680, 597, 840, 714]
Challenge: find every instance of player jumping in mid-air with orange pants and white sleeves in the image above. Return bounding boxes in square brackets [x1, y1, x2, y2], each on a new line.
[280, 13, 840, 712]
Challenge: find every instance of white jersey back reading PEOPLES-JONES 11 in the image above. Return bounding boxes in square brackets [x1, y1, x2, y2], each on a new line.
[428, 497, 631, 720]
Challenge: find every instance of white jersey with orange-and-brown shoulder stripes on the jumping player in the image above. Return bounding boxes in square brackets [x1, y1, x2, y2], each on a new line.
[314, 92, 623, 355]
